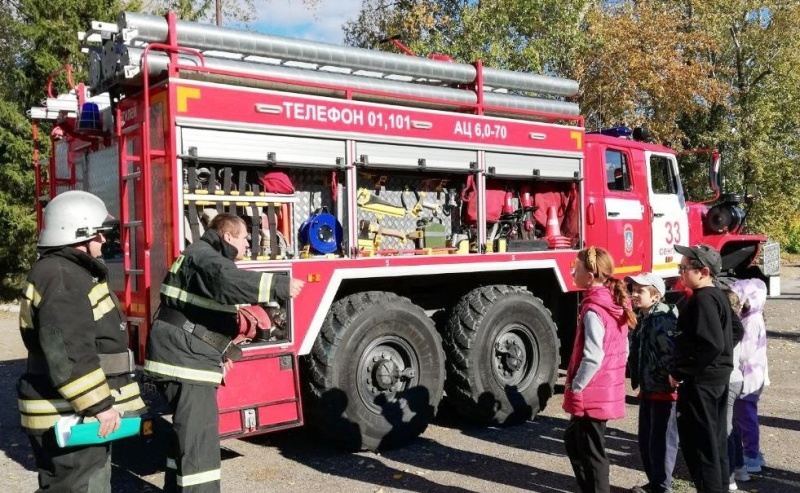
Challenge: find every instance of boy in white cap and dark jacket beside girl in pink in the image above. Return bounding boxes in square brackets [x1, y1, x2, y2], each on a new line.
[626, 273, 678, 493]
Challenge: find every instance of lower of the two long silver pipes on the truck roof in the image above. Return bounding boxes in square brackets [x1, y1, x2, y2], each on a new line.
[115, 45, 579, 118]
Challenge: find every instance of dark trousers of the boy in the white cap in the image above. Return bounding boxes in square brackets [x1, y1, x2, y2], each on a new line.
[639, 399, 678, 493]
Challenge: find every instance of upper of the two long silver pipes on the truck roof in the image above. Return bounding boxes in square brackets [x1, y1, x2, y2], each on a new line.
[118, 12, 578, 96]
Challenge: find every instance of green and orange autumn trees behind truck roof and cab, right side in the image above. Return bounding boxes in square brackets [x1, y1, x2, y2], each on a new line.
[343, 0, 800, 241]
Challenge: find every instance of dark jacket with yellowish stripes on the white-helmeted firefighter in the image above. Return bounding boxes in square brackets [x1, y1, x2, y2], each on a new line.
[17, 247, 145, 434]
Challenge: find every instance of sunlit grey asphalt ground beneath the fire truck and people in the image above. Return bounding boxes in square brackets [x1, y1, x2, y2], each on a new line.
[0, 267, 800, 493]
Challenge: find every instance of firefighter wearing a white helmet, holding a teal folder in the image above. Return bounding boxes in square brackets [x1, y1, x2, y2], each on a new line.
[17, 191, 145, 493]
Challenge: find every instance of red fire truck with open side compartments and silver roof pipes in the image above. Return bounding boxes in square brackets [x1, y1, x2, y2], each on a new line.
[31, 12, 779, 449]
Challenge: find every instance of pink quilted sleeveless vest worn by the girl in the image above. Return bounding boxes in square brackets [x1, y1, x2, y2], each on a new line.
[563, 286, 628, 421]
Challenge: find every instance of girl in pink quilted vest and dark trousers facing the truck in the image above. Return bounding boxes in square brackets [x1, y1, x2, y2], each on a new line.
[563, 247, 636, 493]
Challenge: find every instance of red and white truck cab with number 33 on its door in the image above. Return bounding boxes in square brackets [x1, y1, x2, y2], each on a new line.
[585, 128, 690, 270]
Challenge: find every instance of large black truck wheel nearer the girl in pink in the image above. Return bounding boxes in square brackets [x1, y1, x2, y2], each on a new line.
[443, 286, 559, 424]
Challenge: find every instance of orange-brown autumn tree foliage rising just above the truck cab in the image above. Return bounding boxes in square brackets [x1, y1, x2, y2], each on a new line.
[577, 2, 729, 142]
